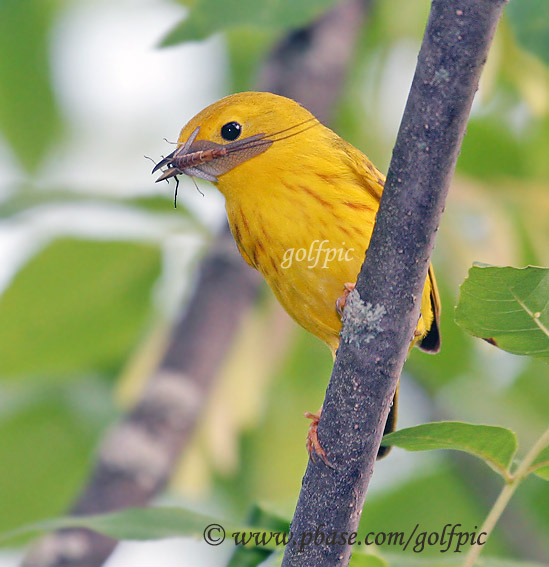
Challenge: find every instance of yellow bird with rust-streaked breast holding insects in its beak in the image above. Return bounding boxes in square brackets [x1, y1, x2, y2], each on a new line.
[153, 92, 441, 465]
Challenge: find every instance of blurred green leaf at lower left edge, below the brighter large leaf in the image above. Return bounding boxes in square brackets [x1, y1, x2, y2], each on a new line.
[0, 379, 115, 532]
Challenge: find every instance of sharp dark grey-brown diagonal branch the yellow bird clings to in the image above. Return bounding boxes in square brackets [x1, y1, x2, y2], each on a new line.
[282, 0, 505, 567]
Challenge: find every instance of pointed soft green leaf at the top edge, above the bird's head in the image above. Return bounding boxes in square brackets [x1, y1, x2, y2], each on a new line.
[162, 0, 335, 46]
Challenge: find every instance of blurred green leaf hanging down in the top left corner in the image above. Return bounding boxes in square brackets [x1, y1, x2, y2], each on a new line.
[0, 0, 61, 171]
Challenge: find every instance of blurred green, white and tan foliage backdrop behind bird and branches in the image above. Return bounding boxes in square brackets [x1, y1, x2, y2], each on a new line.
[0, 0, 549, 564]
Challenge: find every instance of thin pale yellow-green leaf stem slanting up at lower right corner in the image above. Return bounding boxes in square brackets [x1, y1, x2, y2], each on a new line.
[463, 429, 549, 567]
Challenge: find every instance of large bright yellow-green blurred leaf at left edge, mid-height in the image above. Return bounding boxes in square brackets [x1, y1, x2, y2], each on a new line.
[0, 239, 160, 380]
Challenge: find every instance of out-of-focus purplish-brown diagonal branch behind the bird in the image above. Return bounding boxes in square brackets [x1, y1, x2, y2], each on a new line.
[23, 0, 370, 567]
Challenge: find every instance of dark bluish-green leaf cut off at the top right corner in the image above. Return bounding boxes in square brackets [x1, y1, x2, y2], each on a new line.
[506, 0, 549, 64]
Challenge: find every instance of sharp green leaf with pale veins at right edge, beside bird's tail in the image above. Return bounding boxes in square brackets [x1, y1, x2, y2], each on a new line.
[456, 266, 549, 361]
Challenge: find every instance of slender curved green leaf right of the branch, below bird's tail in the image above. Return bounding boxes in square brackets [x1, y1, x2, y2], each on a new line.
[383, 421, 517, 477]
